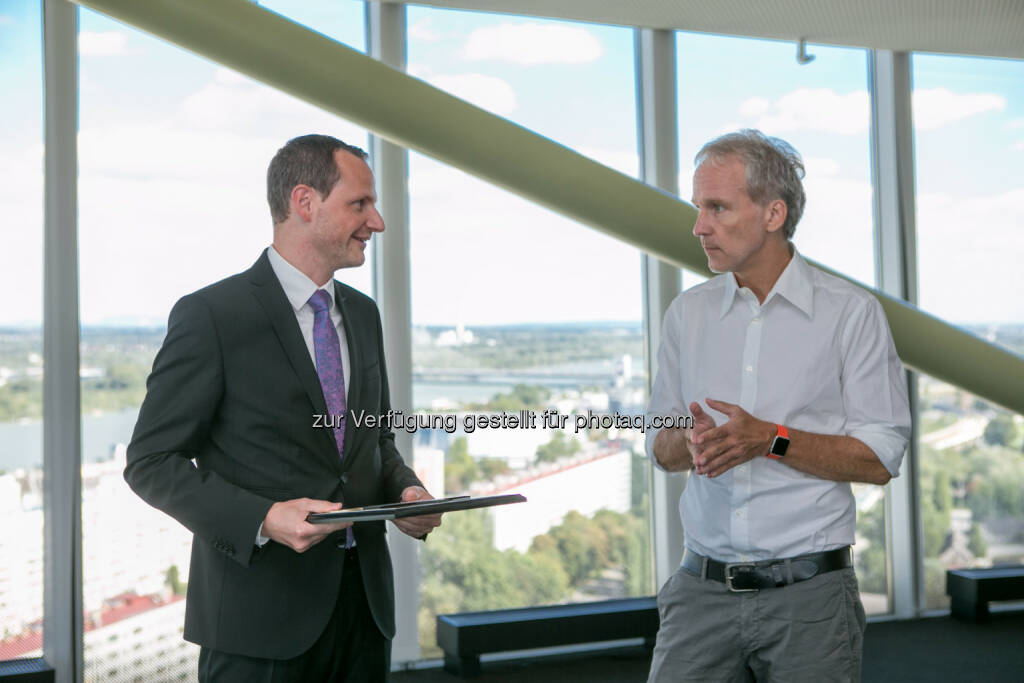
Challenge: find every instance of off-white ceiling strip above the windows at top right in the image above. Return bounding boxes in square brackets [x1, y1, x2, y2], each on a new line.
[384, 0, 1024, 58]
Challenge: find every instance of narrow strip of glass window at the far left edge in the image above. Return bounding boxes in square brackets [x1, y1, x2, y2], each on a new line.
[0, 0, 43, 660]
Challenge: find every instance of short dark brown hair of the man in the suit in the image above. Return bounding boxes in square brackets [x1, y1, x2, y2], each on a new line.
[266, 135, 367, 225]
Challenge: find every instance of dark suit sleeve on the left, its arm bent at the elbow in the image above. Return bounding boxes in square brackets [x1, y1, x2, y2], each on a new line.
[125, 295, 272, 565]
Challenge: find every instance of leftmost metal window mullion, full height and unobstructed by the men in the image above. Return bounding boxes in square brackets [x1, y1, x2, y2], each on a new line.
[43, 0, 83, 683]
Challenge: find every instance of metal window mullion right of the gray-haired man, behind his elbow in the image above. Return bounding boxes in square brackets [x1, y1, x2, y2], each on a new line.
[868, 50, 924, 618]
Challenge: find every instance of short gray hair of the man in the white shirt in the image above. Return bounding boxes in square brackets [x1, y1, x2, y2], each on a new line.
[693, 128, 807, 240]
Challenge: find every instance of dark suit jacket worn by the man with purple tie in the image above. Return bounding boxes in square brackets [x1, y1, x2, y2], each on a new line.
[125, 252, 420, 658]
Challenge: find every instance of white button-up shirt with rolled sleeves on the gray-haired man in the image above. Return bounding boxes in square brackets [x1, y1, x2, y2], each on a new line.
[647, 250, 910, 562]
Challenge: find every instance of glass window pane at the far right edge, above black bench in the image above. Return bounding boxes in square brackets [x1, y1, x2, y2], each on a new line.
[912, 54, 1024, 607]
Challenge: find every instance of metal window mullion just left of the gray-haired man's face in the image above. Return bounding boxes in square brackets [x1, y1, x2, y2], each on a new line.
[634, 29, 686, 588]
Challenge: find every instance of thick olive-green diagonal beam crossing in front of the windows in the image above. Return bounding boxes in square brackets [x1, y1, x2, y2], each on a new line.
[78, 0, 1024, 413]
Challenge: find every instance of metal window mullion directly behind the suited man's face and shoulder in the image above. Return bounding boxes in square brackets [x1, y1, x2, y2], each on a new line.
[366, 2, 420, 664]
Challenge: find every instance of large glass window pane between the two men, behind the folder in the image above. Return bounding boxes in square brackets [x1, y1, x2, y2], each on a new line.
[409, 7, 653, 655]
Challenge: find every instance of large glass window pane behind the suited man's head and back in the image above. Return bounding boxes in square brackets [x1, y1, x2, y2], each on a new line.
[77, 2, 371, 681]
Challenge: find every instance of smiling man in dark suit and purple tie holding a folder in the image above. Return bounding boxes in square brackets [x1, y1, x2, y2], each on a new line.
[125, 135, 440, 681]
